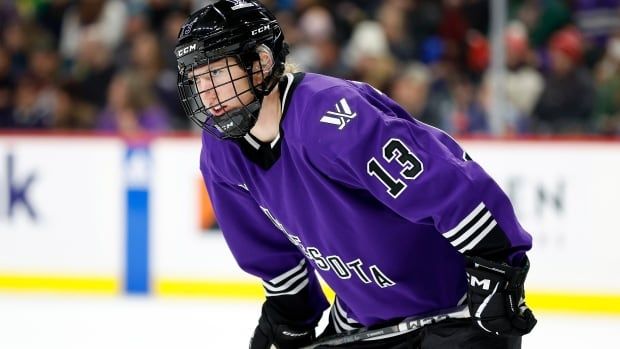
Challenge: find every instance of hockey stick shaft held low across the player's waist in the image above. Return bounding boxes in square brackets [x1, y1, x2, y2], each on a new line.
[301, 304, 470, 349]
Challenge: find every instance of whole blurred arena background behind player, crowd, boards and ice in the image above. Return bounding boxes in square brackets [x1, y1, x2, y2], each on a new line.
[0, 0, 620, 348]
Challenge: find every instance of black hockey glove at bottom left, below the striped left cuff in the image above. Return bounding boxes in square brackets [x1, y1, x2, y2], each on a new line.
[250, 308, 315, 349]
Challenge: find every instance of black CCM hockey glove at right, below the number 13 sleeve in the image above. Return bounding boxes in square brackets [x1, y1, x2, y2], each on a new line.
[466, 257, 536, 336]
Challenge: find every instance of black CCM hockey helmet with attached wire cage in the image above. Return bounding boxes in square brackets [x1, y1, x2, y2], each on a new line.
[175, 0, 288, 138]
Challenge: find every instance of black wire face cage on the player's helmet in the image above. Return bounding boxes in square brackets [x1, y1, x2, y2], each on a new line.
[178, 55, 267, 139]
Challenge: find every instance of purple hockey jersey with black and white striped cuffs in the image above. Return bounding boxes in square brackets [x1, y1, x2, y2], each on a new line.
[201, 73, 531, 330]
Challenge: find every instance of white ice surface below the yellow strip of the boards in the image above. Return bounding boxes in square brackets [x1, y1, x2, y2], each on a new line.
[0, 293, 620, 349]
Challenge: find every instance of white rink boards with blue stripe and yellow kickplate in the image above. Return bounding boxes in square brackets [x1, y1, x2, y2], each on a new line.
[0, 134, 620, 315]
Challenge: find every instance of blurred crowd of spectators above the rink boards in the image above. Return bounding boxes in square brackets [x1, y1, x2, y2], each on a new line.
[0, 0, 620, 136]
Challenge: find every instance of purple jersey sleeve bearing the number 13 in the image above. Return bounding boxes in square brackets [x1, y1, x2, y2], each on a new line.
[308, 86, 531, 264]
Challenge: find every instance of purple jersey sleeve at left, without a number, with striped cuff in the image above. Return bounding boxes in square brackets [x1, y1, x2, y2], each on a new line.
[201, 141, 328, 324]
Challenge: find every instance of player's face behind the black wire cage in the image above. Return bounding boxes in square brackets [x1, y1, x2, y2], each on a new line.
[193, 57, 254, 117]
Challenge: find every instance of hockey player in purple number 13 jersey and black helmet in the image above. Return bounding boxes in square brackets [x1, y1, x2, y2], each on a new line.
[175, 1, 536, 349]
